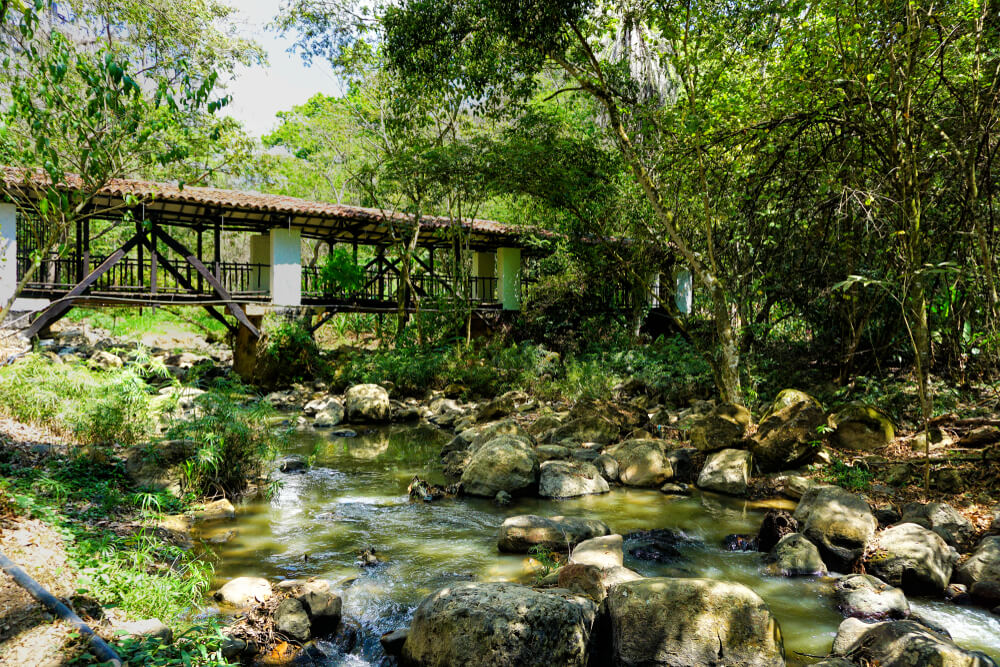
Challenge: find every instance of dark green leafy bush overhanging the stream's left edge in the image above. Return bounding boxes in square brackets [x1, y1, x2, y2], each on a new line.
[166, 382, 277, 498]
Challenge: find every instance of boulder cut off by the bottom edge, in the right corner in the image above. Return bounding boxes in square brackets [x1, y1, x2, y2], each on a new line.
[834, 619, 996, 667]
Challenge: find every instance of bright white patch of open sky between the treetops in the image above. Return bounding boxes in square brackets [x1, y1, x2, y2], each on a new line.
[219, 0, 340, 137]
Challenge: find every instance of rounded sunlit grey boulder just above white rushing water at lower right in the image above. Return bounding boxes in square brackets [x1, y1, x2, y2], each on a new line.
[865, 523, 958, 595]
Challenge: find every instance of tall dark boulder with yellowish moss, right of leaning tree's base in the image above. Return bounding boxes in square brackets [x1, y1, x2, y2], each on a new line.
[750, 400, 826, 472]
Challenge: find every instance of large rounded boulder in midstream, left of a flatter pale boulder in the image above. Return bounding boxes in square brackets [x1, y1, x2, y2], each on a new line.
[462, 435, 539, 498]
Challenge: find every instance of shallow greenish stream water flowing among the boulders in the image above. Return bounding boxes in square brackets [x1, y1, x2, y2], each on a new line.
[205, 427, 1000, 665]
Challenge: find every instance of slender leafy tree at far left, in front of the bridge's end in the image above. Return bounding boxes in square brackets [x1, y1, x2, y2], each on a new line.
[0, 2, 258, 320]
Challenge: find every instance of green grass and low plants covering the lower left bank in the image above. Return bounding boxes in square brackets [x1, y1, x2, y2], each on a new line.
[0, 448, 233, 666]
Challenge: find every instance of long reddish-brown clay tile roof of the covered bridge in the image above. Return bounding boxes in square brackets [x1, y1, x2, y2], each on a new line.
[0, 167, 559, 249]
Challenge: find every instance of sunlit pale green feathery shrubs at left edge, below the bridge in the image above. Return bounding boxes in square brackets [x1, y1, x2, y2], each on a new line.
[0, 354, 151, 445]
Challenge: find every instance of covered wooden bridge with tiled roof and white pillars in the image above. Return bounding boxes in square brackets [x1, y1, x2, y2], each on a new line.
[0, 167, 556, 338]
